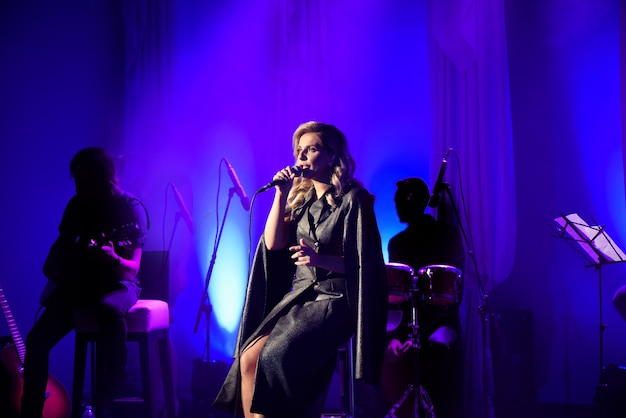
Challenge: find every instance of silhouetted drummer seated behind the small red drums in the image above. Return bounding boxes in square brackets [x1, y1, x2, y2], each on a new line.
[382, 177, 465, 418]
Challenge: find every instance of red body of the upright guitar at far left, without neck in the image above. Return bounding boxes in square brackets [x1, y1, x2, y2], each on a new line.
[0, 345, 70, 418]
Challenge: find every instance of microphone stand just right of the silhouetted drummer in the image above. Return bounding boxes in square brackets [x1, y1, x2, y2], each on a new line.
[437, 182, 500, 417]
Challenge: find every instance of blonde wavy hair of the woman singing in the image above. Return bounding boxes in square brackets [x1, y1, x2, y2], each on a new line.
[287, 121, 356, 210]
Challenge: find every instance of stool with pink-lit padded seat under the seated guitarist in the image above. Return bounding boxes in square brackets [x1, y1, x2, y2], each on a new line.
[72, 299, 176, 418]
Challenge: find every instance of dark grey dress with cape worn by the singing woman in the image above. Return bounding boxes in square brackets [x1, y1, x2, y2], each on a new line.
[215, 185, 387, 418]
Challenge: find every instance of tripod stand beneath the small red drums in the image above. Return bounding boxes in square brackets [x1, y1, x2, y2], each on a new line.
[385, 289, 436, 418]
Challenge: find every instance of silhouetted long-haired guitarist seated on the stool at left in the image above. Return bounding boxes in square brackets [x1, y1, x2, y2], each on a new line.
[20, 147, 148, 418]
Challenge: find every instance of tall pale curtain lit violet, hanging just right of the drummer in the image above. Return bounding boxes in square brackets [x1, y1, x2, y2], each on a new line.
[428, 0, 516, 417]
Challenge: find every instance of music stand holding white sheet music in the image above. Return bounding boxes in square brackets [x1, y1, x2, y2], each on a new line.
[554, 213, 626, 375]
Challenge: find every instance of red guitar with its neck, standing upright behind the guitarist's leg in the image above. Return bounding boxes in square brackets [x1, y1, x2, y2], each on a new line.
[0, 287, 71, 418]
